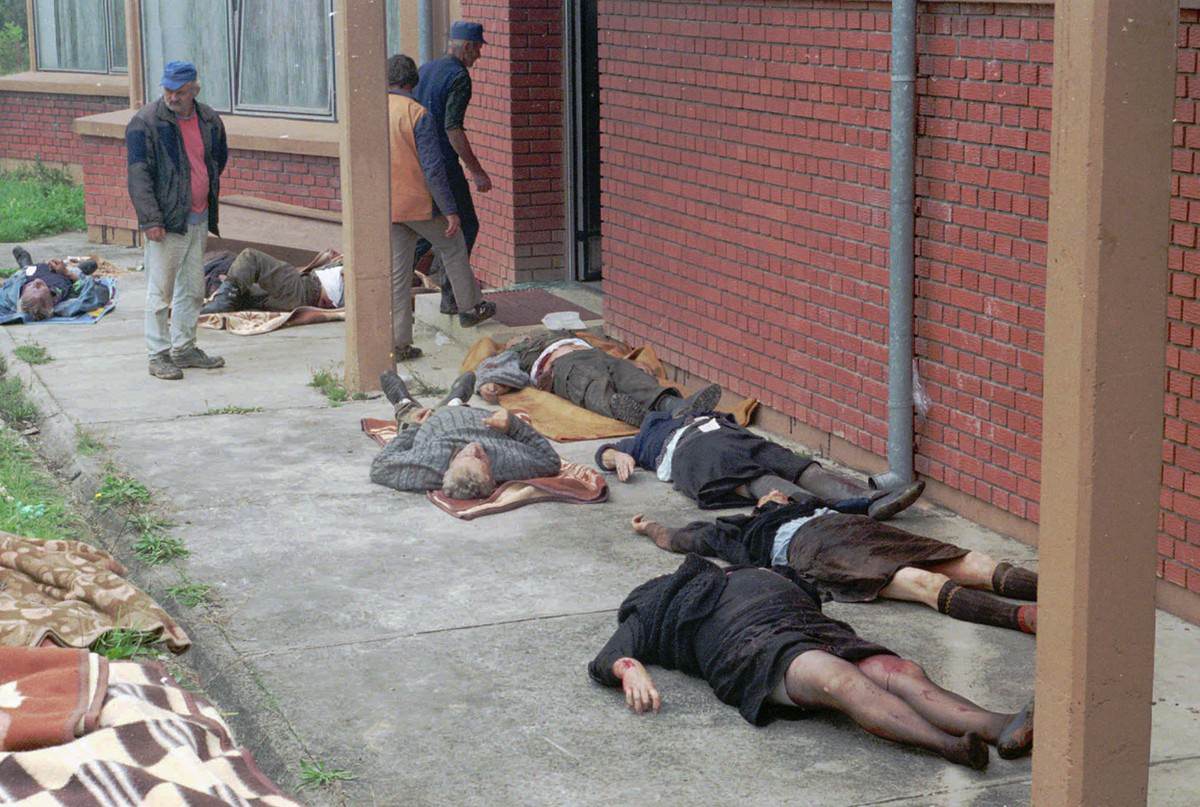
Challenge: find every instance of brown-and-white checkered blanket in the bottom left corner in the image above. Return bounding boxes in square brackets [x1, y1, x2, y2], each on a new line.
[0, 651, 299, 807]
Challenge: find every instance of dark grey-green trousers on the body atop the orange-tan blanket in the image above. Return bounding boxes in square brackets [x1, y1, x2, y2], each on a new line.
[551, 348, 679, 418]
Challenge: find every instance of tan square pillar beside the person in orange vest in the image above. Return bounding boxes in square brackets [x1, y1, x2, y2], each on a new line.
[334, 0, 396, 391]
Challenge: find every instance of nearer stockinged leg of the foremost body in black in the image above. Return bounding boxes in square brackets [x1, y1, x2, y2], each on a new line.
[775, 650, 988, 770]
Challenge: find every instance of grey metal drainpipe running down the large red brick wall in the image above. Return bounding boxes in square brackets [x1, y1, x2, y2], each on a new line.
[871, 0, 917, 488]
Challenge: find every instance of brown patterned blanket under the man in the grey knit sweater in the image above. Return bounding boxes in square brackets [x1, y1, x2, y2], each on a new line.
[352, 418, 608, 521]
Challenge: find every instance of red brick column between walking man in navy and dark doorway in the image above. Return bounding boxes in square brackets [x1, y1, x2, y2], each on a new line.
[462, 0, 565, 286]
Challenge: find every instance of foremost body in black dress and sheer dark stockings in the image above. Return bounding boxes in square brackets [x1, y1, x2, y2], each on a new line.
[588, 555, 1033, 769]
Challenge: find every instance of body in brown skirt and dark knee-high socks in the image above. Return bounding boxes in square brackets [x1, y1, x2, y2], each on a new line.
[632, 491, 1038, 633]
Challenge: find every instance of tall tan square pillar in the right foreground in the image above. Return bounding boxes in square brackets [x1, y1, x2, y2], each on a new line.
[1033, 0, 1180, 807]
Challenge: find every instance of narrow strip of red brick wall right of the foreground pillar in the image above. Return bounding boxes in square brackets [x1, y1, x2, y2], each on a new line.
[1158, 11, 1200, 592]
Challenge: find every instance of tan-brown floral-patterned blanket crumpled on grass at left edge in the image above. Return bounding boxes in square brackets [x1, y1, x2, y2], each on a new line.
[0, 532, 192, 653]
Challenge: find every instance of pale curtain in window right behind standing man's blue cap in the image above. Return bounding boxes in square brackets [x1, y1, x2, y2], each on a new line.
[142, 0, 233, 112]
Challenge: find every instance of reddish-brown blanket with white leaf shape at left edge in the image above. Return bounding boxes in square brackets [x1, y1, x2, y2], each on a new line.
[0, 647, 108, 751]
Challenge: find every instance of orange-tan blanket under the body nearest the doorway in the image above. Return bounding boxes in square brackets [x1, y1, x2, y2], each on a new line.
[461, 330, 758, 443]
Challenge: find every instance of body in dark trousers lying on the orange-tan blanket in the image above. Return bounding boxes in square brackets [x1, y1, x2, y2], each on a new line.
[475, 330, 721, 426]
